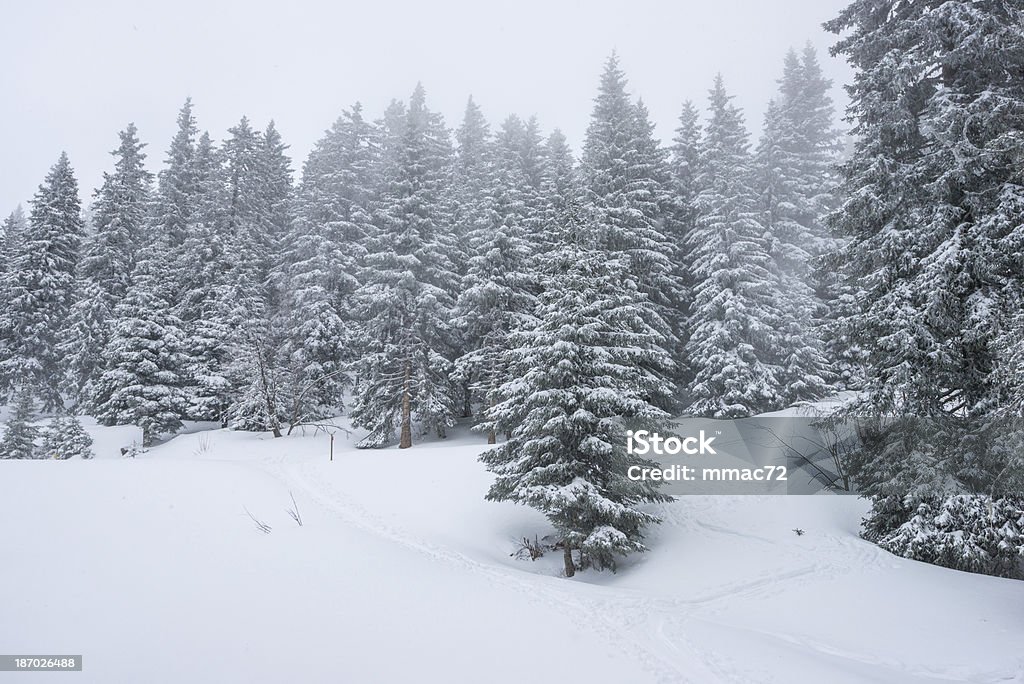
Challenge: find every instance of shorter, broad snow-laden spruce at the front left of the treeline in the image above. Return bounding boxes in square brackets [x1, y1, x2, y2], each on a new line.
[91, 243, 185, 446]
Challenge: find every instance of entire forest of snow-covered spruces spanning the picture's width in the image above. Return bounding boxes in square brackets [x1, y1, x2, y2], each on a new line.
[0, 0, 1024, 574]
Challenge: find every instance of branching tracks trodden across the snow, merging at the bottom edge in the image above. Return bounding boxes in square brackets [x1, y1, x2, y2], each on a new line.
[256, 448, 958, 684]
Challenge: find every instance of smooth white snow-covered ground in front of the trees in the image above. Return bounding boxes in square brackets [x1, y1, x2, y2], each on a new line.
[0, 419, 1024, 684]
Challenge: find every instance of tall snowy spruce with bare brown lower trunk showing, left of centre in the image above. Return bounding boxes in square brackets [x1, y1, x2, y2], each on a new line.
[351, 85, 458, 447]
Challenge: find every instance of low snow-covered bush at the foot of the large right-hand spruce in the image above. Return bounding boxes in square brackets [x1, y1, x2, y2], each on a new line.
[879, 495, 1024, 580]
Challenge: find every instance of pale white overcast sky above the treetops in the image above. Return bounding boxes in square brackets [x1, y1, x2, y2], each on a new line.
[0, 0, 850, 218]
